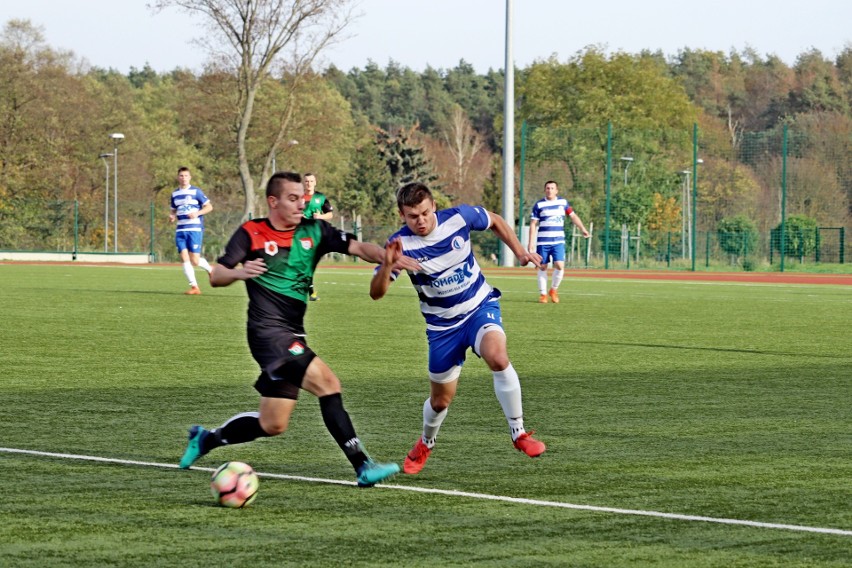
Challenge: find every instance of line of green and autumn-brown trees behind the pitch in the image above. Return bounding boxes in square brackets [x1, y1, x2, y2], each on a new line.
[0, 16, 852, 258]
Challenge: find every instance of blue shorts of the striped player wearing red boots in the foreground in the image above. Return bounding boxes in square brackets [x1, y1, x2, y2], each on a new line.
[426, 298, 503, 374]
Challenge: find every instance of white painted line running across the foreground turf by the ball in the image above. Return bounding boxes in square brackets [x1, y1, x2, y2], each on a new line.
[0, 447, 852, 536]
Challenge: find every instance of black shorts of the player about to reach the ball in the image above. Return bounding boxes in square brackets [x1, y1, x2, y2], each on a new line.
[248, 327, 316, 400]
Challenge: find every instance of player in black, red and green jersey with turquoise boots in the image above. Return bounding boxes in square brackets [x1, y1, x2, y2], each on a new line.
[180, 172, 417, 487]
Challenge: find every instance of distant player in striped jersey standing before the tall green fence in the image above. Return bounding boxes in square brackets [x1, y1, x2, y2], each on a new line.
[529, 181, 589, 304]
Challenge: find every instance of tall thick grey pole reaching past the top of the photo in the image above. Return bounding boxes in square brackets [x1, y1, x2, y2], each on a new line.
[500, 0, 515, 266]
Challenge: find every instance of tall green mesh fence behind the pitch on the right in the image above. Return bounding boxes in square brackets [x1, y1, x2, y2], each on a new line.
[518, 124, 852, 270]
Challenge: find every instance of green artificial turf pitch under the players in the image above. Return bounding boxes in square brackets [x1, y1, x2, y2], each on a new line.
[0, 264, 852, 567]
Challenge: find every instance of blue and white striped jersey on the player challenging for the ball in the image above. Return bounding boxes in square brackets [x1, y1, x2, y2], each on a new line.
[388, 205, 494, 331]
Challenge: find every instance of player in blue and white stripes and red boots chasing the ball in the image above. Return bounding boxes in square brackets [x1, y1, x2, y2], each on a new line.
[370, 183, 546, 474]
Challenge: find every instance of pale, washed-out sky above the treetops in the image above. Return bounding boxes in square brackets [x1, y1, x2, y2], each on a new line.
[0, 0, 852, 73]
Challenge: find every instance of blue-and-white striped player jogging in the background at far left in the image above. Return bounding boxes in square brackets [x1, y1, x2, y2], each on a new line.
[169, 166, 213, 295]
